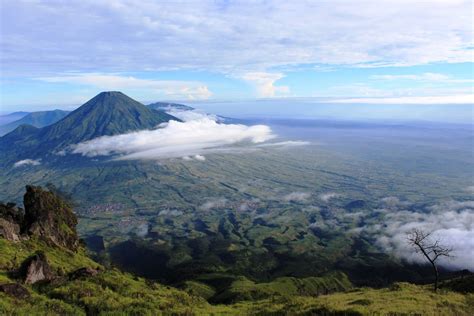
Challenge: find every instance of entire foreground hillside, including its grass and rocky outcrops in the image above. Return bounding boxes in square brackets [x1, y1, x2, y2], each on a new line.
[0, 186, 474, 315]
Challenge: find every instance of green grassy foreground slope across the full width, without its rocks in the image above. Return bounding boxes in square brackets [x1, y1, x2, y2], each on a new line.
[0, 239, 474, 315]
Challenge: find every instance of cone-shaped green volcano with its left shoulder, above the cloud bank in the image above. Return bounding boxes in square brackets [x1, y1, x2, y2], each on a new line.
[0, 91, 179, 162]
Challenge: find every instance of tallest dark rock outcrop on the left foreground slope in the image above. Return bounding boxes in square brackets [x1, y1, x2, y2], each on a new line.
[22, 185, 79, 250]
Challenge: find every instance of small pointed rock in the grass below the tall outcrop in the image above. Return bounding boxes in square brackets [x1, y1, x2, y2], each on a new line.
[20, 252, 54, 284]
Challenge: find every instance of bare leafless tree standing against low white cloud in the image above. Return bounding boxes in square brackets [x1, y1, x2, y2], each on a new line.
[408, 228, 453, 292]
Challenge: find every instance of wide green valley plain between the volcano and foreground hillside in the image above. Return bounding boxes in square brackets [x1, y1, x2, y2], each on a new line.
[0, 135, 470, 286]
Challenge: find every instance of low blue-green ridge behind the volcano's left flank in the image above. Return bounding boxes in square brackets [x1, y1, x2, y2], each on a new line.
[0, 110, 70, 136]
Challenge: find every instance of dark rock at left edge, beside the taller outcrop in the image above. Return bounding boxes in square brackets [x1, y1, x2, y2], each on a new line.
[0, 203, 23, 241]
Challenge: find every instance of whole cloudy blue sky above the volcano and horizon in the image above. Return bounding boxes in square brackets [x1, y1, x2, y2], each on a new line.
[0, 0, 474, 116]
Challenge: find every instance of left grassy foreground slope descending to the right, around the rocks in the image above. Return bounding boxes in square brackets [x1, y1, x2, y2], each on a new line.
[0, 238, 209, 315]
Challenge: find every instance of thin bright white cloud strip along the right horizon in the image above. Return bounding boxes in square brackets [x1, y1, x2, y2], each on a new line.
[327, 94, 474, 104]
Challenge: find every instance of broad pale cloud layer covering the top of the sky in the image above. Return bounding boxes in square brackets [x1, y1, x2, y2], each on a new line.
[2, 0, 473, 73]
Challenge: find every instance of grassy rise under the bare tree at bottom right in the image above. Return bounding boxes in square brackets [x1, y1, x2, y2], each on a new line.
[225, 283, 474, 315]
